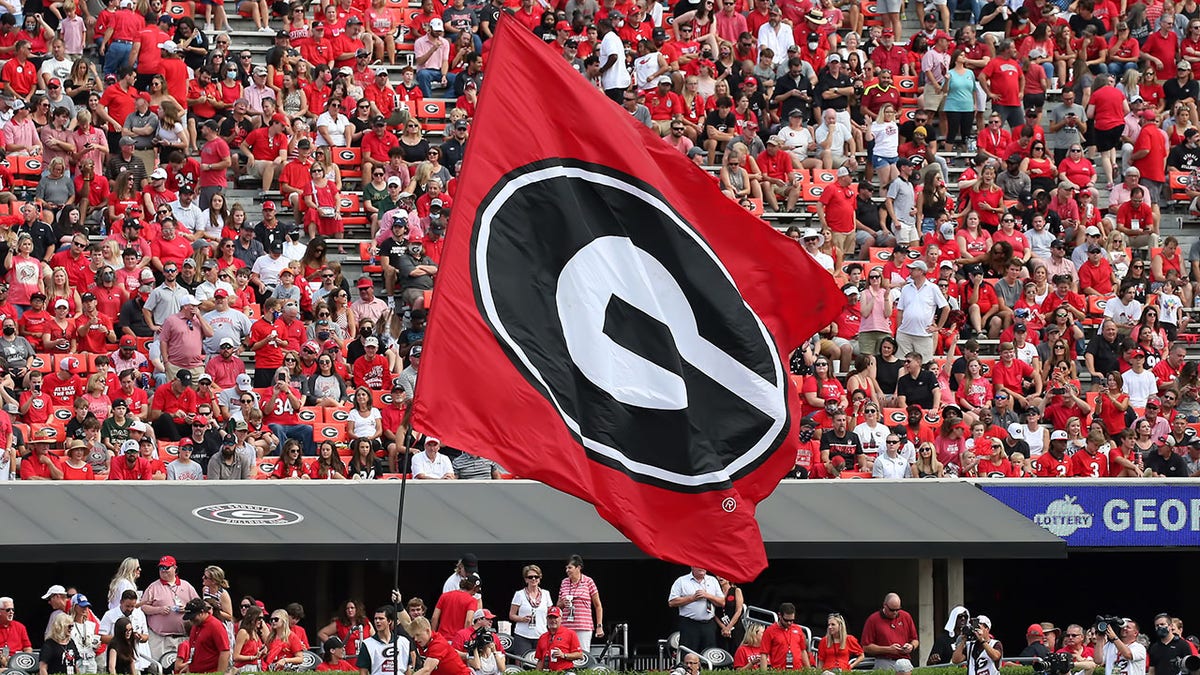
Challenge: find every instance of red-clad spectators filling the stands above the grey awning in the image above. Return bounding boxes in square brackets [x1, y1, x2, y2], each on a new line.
[0, 0, 1200, 480]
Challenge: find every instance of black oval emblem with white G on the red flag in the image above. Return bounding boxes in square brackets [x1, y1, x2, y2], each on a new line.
[470, 159, 788, 491]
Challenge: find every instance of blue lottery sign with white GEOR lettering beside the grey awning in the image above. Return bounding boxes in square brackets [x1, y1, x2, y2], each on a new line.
[980, 480, 1200, 548]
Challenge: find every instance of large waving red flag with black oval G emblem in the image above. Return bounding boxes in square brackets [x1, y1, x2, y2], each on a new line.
[414, 19, 845, 581]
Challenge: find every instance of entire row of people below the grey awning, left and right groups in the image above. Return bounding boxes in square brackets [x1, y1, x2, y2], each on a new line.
[0, 554, 1198, 675]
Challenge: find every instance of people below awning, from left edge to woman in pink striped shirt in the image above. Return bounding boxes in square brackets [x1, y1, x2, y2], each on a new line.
[0, 554, 605, 675]
